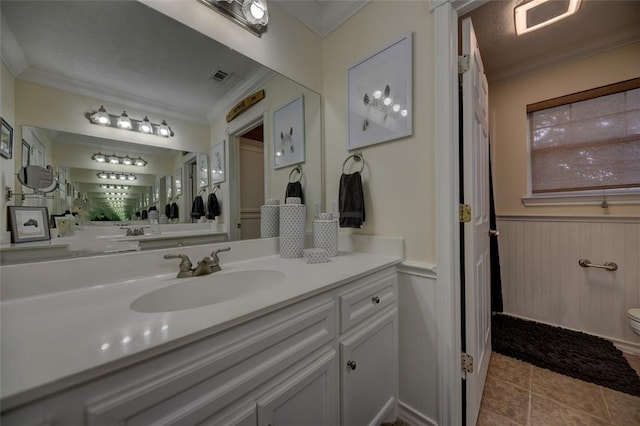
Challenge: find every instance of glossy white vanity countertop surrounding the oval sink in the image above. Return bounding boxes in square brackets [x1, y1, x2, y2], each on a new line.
[0, 252, 401, 409]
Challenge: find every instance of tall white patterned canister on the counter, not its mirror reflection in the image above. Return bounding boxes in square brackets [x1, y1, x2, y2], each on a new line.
[280, 197, 307, 259]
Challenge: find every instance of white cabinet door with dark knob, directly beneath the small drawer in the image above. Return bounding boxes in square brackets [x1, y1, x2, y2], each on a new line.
[340, 307, 398, 426]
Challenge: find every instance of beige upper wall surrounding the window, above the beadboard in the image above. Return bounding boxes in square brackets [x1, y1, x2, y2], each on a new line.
[489, 43, 640, 216]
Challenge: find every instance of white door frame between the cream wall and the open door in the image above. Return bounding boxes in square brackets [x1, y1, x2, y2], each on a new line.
[432, 0, 488, 425]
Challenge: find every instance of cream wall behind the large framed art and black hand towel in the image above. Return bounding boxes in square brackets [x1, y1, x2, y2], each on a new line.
[322, 1, 436, 263]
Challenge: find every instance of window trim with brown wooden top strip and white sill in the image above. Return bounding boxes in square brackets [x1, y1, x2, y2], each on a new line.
[521, 77, 640, 203]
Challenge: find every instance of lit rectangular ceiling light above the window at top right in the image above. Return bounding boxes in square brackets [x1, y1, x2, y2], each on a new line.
[514, 0, 582, 35]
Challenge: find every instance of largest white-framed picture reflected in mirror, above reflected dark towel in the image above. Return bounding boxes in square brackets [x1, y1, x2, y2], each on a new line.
[273, 95, 305, 169]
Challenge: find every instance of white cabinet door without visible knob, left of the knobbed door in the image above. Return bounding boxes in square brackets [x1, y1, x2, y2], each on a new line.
[258, 349, 339, 426]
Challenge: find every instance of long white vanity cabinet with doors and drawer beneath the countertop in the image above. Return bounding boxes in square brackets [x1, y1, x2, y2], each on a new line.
[0, 267, 398, 426]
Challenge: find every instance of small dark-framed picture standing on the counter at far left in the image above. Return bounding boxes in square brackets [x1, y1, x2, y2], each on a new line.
[7, 206, 51, 243]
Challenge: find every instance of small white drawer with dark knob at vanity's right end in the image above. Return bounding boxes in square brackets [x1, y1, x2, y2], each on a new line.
[340, 271, 398, 333]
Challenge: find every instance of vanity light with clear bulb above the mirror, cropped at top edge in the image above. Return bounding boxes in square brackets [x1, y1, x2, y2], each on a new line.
[198, 0, 269, 37]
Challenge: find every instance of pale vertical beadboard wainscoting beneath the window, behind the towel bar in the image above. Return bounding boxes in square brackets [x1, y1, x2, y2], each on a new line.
[498, 217, 640, 345]
